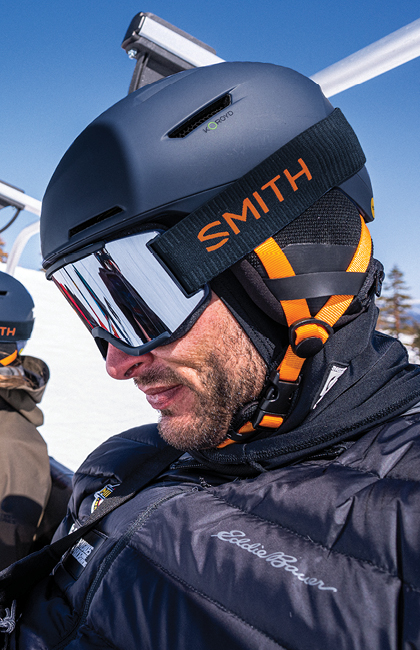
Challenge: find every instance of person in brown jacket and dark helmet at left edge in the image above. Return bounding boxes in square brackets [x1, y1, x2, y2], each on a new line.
[0, 272, 51, 569]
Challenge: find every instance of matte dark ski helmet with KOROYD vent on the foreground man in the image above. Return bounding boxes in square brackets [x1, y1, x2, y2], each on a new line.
[41, 63, 373, 268]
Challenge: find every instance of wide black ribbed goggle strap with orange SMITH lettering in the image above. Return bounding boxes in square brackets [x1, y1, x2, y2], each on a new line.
[150, 108, 366, 293]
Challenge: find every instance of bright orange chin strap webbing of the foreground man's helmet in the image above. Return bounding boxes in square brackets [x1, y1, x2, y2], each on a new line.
[219, 216, 372, 448]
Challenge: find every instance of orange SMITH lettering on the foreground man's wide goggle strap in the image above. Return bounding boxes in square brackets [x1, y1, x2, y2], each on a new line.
[197, 156, 312, 252]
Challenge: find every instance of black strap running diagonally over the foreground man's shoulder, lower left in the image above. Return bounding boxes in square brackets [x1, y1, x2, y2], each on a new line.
[0, 446, 183, 604]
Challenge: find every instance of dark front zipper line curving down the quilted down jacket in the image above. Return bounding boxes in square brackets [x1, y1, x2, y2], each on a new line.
[53, 489, 182, 650]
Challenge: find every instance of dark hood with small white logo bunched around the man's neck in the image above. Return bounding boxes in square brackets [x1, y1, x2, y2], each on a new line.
[191, 303, 420, 476]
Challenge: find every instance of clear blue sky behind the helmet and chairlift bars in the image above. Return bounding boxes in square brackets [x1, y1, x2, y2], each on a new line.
[0, 0, 420, 300]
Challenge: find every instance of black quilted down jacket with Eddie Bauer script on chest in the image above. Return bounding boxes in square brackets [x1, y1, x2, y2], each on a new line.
[11, 310, 420, 650]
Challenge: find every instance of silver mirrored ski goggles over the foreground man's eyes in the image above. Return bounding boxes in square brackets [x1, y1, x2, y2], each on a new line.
[48, 230, 210, 356]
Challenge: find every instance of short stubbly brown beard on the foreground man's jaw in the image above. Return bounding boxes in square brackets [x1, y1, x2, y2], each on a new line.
[135, 326, 266, 451]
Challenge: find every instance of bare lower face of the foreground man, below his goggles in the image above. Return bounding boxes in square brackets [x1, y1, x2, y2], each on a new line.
[106, 296, 266, 450]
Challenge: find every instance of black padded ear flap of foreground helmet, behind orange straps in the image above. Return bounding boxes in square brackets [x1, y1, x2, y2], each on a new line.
[211, 189, 382, 365]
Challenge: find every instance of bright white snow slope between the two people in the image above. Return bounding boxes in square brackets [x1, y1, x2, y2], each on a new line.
[0, 264, 157, 470]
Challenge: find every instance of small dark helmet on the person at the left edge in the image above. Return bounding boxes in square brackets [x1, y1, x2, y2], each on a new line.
[0, 271, 34, 365]
